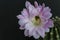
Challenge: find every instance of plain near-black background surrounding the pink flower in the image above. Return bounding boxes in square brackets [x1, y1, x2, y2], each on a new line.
[0, 0, 60, 40]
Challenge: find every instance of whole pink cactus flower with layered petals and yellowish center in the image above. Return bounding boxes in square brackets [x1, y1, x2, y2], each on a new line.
[17, 1, 54, 39]
